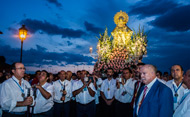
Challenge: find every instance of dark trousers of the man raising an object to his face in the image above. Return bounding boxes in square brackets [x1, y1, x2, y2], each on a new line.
[76, 101, 96, 117]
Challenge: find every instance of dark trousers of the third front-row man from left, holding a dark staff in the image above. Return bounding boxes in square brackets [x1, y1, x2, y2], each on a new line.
[53, 102, 70, 117]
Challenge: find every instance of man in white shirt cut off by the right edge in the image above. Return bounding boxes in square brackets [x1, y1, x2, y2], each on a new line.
[173, 69, 190, 117]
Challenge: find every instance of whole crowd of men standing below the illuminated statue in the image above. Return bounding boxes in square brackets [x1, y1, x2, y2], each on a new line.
[0, 62, 190, 117]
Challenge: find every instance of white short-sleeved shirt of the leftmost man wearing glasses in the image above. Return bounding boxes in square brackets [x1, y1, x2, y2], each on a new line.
[0, 76, 33, 112]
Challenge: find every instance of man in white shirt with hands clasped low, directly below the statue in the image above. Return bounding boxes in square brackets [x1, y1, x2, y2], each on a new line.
[100, 68, 116, 117]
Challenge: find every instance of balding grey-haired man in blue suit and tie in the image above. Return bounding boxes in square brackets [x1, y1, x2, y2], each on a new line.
[133, 65, 173, 117]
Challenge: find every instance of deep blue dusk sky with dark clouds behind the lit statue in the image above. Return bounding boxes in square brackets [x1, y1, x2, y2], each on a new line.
[0, 0, 190, 73]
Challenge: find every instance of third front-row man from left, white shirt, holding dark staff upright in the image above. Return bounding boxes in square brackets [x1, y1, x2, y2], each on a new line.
[53, 70, 72, 117]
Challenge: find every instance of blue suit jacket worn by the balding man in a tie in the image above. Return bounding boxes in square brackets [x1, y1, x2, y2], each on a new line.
[133, 80, 173, 117]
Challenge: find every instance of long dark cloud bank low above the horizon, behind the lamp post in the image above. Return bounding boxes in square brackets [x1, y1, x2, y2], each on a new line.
[0, 45, 93, 66]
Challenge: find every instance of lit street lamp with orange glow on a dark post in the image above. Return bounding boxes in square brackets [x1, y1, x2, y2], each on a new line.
[19, 25, 28, 63]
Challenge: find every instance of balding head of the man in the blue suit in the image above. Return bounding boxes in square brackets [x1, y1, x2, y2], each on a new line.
[140, 64, 157, 85]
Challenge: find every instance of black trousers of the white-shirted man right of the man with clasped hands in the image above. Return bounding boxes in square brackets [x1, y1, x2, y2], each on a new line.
[115, 100, 133, 117]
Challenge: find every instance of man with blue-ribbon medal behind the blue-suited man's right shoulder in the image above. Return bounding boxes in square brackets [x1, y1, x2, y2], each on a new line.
[166, 65, 185, 111]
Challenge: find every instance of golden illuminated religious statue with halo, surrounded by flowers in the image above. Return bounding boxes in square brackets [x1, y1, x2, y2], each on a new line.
[93, 11, 147, 73]
